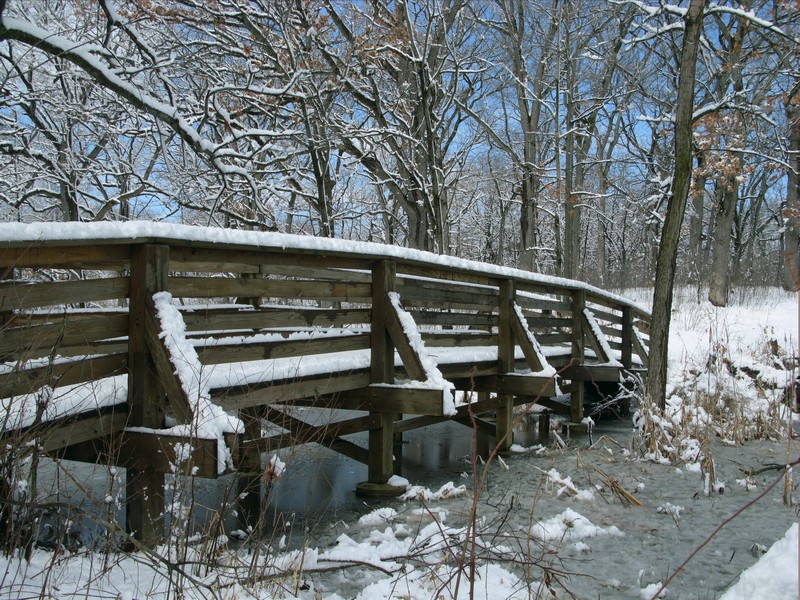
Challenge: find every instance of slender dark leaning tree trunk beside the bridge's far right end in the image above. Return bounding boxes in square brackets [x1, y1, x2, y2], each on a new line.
[646, 0, 706, 409]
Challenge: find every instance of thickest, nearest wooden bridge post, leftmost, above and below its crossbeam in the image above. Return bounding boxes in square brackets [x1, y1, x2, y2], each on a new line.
[125, 244, 169, 545]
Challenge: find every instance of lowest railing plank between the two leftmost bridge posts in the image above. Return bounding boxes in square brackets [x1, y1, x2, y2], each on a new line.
[197, 333, 370, 365]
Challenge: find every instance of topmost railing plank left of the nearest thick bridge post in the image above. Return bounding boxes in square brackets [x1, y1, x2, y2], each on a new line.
[0, 241, 130, 270]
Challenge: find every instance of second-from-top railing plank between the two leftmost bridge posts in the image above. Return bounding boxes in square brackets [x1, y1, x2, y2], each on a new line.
[170, 277, 371, 302]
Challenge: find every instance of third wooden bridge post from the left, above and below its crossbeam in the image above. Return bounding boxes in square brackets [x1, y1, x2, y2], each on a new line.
[495, 279, 516, 452]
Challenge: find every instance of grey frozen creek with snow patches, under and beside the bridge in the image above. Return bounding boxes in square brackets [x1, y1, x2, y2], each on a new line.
[28, 419, 798, 600]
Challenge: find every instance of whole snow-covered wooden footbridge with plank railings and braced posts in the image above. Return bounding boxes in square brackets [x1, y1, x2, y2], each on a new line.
[0, 223, 649, 541]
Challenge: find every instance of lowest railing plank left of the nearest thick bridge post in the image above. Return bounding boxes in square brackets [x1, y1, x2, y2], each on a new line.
[0, 352, 128, 398]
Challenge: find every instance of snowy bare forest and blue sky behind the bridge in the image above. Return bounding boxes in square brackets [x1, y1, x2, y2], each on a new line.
[0, 0, 800, 305]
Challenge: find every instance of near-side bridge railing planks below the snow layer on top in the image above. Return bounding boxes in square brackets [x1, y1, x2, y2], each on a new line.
[0, 230, 649, 436]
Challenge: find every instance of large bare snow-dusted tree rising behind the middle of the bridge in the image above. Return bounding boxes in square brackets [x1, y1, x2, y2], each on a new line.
[310, 0, 482, 253]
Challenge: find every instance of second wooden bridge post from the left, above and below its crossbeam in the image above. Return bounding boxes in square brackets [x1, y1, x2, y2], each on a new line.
[361, 260, 397, 492]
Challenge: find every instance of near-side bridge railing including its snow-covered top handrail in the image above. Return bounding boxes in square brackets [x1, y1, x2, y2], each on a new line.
[0, 222, 650, 428]
